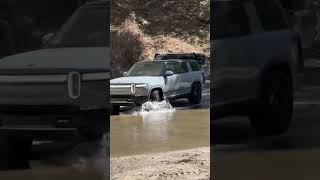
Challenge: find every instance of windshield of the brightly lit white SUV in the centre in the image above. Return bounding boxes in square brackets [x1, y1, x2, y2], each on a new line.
[127, 62, 164, 76]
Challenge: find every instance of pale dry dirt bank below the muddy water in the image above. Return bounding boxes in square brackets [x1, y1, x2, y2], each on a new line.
[110, 147, 210, 180]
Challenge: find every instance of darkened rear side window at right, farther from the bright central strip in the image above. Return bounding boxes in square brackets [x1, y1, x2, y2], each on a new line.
[254, 0, 287, 31]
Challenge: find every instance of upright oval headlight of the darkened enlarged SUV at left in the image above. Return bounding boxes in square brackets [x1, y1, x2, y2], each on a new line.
[68, 72, 81, 99]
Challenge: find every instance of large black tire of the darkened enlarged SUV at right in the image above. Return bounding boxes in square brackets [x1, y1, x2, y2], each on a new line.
[251, 70, 293, 135]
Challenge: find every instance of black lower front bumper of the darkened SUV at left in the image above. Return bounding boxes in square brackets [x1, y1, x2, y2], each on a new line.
[0, 106, 109, 140]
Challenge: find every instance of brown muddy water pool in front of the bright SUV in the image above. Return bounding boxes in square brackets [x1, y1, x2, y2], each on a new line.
[110, 109, 210, 157]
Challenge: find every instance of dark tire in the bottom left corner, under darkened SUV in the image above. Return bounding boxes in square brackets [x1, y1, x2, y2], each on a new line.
[0, 136, 32, 170]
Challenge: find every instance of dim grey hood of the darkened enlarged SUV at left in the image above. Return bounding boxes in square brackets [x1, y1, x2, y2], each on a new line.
[0, 47, 110, 74]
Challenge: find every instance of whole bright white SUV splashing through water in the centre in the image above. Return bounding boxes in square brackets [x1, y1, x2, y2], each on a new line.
[110, 59, 203, 114]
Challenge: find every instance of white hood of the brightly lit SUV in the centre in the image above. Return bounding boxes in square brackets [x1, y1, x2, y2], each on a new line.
[110, 76, 164, 86]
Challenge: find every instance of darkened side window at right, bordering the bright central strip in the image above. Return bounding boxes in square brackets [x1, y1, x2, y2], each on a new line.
[211, 1, 251, 39]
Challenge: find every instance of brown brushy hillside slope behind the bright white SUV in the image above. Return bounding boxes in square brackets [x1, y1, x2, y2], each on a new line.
[111, 0, 210, 76]
